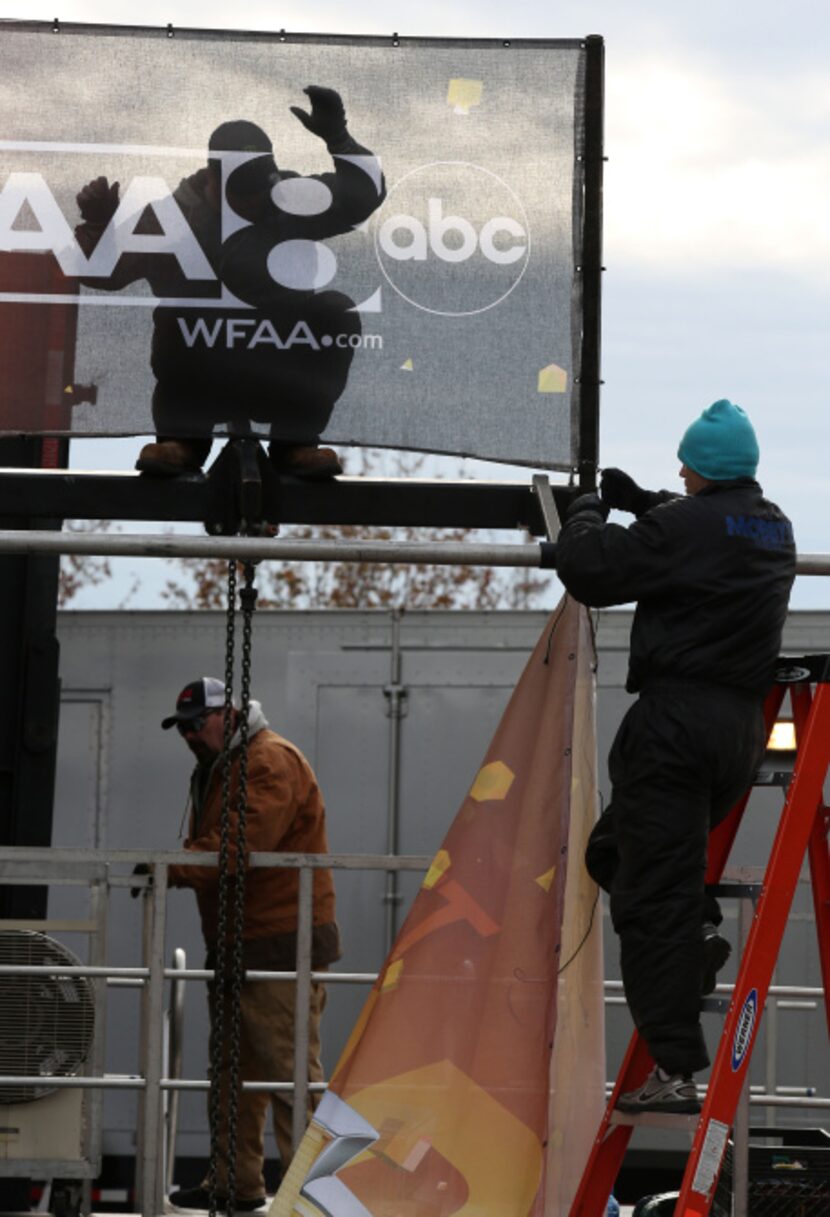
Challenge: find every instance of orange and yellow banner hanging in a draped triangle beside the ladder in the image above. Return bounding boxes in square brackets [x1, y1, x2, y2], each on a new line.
[270, 598, 605, 1217]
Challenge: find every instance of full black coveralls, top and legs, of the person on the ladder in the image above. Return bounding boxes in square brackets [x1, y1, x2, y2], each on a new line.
[556, 478, 795, 1073]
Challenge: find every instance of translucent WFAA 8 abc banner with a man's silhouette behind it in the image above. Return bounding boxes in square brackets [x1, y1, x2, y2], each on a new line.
[0, 22, 598, 469]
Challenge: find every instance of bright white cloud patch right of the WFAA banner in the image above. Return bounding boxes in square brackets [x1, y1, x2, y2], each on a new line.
[605, 57, 830, 279]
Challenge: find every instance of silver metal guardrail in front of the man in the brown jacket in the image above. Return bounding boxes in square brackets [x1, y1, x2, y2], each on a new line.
[0, 847, 830, 1217]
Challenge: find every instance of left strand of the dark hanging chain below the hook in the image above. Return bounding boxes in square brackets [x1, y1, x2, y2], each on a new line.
[208, 561, 236, 1217]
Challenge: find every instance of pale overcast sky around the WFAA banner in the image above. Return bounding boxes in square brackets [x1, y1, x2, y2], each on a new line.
[0, 0, 830, 609]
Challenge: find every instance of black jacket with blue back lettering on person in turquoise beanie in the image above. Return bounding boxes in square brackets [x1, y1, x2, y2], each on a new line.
[556, 478, 796, 696]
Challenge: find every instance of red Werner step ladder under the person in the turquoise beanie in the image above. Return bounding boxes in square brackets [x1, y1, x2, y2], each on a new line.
[570, 655, 830, 1217]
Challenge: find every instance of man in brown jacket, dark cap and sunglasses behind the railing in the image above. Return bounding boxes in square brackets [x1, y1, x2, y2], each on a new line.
[162, 677, 340, 1212]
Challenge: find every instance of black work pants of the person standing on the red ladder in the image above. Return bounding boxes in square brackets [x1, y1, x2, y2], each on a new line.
[585, 684, 765, 1073]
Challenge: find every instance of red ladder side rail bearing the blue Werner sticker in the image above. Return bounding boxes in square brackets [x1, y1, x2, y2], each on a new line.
[674, 684, 830, 1217]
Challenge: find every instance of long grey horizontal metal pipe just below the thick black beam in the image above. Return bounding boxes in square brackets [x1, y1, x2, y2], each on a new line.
[0, 529, 830, 574]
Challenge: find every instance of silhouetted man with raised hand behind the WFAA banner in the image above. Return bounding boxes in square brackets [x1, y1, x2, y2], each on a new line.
[75, 85, 385, 477]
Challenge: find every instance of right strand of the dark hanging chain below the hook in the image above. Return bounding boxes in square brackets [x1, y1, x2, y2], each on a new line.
[226, 562, 257, 1217]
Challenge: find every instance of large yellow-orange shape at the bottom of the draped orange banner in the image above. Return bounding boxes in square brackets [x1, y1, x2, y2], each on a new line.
[342, 1060, 543, 1217]
